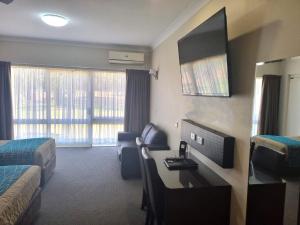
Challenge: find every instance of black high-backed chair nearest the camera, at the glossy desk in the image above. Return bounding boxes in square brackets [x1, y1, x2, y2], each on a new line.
[141, 148, 164, 225]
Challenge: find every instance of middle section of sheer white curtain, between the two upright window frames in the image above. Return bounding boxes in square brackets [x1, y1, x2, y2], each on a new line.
[49, 69, 91, 144]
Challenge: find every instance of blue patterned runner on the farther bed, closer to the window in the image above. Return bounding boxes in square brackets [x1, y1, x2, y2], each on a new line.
[0, 138, 49, 165]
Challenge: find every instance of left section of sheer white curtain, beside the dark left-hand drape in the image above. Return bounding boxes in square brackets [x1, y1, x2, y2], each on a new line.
[12, 66, 49, 138]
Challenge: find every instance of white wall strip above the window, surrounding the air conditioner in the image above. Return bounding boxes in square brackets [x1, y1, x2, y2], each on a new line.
[0, 37, 151, 70]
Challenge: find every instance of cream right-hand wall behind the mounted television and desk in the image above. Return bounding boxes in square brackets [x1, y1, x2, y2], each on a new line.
[151, 0, 300, 225]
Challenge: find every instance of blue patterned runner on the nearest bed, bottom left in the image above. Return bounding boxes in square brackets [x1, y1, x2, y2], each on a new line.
[0, 165, 30, 196]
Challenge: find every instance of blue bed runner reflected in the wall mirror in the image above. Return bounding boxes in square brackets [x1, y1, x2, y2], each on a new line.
[259, 135, 300, 167]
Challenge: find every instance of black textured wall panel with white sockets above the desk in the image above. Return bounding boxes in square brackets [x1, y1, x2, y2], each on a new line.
[181, 120, 235, 168]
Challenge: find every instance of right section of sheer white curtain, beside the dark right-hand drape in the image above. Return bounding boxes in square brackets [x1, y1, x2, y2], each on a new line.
[93, 71, 126, 144]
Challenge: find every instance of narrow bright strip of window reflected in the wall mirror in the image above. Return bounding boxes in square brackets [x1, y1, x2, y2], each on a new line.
[251, 77, 262, 136]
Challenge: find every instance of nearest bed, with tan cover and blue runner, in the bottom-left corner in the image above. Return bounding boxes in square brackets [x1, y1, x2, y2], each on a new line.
[0, 165, 41, 225]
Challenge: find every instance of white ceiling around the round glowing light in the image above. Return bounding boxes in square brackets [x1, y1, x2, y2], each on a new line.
[0, 0, 205, 46]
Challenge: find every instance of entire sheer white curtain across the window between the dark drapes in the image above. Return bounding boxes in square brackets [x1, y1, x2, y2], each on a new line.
[12, 66, 126, 145]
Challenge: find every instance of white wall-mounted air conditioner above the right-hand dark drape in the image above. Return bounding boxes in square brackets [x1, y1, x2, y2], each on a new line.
[108, 51, 145, 64]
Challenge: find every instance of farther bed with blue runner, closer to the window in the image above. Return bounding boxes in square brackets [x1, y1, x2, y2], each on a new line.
[0, 138, 56, 185]
